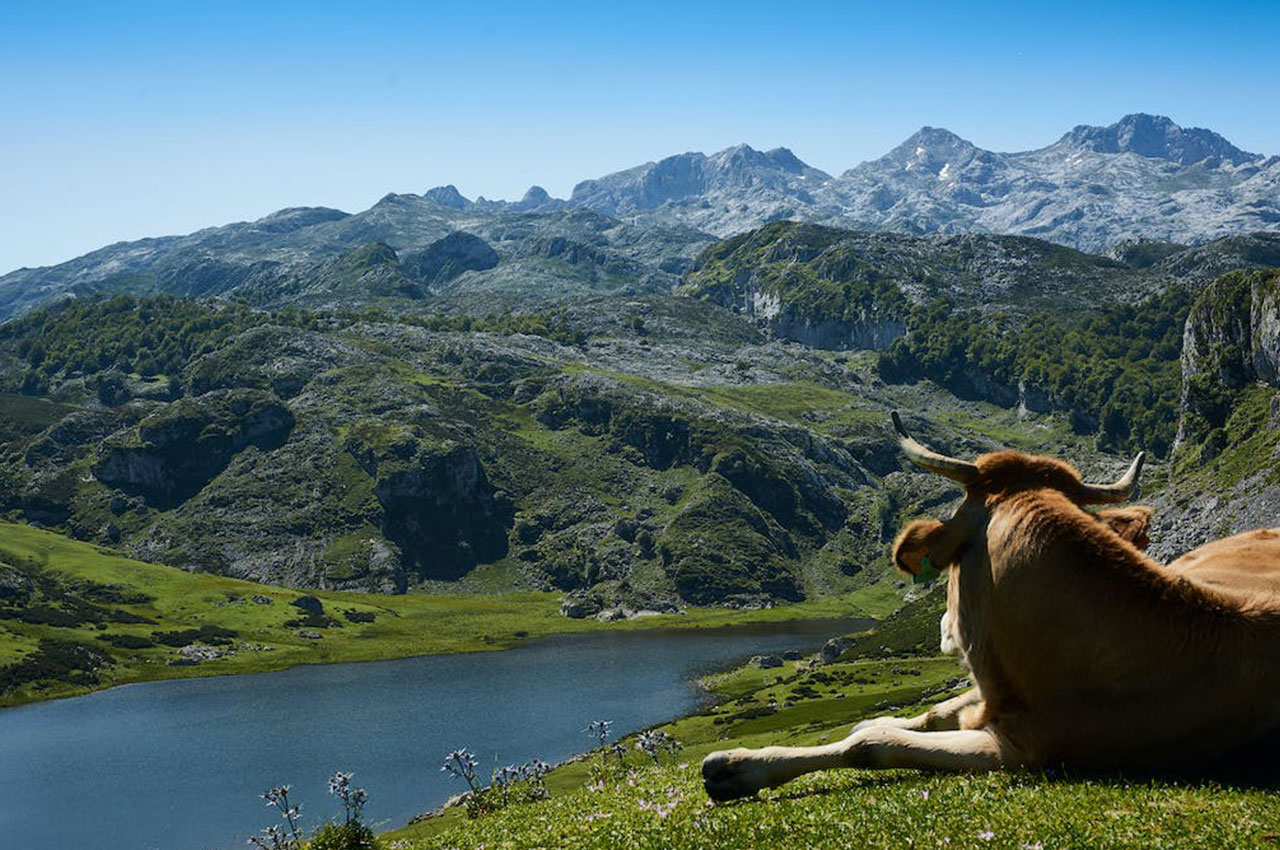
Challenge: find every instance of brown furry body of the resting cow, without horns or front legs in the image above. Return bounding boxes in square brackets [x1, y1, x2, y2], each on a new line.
[948, 452, 1280, 767]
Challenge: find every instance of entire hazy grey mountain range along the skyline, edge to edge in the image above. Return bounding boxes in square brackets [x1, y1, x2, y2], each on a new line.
[0, 114, 1280, 320]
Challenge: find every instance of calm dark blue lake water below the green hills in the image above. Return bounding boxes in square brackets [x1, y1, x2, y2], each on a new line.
[0, 620, 869, 850]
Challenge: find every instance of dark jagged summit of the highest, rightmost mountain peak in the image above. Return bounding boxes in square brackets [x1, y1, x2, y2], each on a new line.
[1059, 113, 1258, 165]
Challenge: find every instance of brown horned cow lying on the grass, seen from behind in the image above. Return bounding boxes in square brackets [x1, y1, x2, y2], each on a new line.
[701, 411, 1280, 800]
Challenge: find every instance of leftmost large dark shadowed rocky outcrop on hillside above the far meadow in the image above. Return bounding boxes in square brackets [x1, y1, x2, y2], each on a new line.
[93, 389, 293, 509]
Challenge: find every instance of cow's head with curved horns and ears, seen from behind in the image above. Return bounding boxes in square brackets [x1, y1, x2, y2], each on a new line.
[892, 411, 1151, 580]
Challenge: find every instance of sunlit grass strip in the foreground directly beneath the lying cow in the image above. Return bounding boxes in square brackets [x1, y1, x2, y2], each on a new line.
[388, 760, 1280, 850]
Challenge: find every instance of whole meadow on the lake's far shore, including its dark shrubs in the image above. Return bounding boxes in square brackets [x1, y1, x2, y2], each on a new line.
[0, 522, 899, 705]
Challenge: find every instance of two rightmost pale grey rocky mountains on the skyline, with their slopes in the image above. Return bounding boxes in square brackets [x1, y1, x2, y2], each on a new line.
[829, 115, 1280, 251]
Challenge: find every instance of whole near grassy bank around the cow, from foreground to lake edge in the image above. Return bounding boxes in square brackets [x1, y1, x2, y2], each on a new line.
[386, 598, 1280, 850]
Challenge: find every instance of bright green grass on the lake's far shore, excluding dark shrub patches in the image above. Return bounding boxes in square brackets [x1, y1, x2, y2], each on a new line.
[0, 522, 896, 705]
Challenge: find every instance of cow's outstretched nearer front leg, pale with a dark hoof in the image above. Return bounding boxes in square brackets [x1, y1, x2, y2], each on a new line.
[703, 726, 1012, 800]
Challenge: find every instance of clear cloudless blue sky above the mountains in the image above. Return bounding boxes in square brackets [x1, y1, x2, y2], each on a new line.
[0, 0, 1280, 273]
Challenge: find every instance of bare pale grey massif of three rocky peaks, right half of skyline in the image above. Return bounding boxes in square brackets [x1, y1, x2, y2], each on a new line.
[571, 114, 1280, 251]
